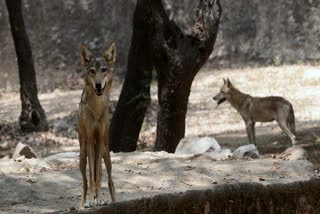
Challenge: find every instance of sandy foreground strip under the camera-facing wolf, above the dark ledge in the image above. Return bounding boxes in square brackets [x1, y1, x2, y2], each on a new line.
[0, 152, 313, 213]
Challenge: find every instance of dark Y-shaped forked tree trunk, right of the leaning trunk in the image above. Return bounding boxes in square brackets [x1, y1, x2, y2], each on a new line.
[138, 0, 221, 153]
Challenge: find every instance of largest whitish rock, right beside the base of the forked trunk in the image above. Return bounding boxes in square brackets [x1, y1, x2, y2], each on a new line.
[175, 137, 221, 155]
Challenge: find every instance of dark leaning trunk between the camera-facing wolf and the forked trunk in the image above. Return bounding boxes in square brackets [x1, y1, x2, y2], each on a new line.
[110, 4, 153, 152]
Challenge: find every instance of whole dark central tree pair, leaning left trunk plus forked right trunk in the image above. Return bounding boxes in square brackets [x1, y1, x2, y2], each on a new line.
[110, 0, 222, 152]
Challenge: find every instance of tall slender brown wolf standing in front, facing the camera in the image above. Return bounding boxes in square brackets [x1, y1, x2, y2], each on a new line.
[78, 43, 116, 208]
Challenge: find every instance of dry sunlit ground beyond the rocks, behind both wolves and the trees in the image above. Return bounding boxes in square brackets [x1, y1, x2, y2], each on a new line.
[0, 65, 320, 168]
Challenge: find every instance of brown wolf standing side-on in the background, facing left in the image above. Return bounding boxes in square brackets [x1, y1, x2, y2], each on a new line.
[213, 79, 296, 145]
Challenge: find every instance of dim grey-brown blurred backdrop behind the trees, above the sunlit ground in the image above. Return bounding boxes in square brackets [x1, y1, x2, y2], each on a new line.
[0, 0, 320, 90]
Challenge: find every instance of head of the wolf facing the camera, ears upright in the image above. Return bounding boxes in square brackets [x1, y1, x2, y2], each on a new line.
[80, 42, 116, 96]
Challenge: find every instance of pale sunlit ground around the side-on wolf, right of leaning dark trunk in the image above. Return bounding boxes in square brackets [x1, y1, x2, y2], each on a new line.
[140, 66, 320, 166]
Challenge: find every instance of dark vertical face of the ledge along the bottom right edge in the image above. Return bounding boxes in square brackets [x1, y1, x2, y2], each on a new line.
[78, 179, 320, 214]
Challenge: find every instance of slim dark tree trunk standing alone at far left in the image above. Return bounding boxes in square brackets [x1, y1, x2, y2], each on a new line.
[6, 0, 48, 131]
